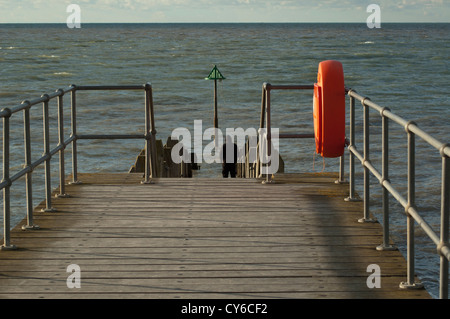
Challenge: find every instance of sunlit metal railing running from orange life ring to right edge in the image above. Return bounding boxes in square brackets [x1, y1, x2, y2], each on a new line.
[346, 88, 450, 299]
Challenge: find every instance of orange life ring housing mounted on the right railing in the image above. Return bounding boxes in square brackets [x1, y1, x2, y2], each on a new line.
[313, 60, 345, 157]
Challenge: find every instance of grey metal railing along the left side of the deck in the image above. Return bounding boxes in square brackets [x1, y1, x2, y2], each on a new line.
[0, 83, 156, 250]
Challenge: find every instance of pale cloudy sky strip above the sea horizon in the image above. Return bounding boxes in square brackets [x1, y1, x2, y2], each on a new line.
[0, 0, 450, 24]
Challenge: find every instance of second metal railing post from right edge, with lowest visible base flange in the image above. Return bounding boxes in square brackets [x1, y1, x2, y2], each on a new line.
[400, 121, 423, 289]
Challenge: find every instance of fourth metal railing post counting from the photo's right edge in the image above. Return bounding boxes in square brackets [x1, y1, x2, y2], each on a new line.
[358, 98, 375, 223]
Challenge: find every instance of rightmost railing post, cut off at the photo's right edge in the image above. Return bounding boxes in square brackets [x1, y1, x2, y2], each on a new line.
[438, 148, 450, 299]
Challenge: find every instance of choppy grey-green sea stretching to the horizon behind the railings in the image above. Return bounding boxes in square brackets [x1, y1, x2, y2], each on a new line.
[0, 23, 450, 298]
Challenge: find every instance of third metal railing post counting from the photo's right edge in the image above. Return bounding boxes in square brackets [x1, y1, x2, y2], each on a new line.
[377, 107, 397, 250]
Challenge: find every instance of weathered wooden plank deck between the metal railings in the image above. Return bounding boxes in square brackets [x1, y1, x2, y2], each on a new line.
[0, 174, 430, 299]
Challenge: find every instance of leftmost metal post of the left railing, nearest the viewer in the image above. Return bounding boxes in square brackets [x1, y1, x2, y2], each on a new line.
[1, 108, 17, 250]
